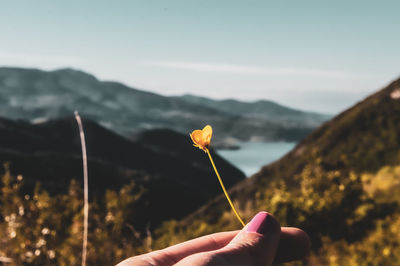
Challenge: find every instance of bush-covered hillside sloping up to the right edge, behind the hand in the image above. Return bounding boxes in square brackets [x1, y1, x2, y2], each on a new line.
[152, 79, 400, 265]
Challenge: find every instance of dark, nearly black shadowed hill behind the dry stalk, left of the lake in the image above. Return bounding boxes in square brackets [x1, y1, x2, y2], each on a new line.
[0, 117, 245, 229]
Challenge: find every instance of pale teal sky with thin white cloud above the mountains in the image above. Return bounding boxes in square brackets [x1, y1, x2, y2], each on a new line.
[0, 0, 400, 114]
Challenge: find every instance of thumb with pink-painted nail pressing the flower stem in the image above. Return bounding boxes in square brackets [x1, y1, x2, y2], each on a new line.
[178, 212, 281, 266]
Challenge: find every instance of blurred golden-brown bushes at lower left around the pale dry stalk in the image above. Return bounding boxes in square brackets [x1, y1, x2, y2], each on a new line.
[0, 164, 148, 265]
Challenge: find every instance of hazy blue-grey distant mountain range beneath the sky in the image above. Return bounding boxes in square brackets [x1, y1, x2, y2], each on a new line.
[0, 67, 327, 145]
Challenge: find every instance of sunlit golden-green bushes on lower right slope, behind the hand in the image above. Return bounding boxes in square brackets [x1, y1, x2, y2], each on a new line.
[154, 164, 400, 265]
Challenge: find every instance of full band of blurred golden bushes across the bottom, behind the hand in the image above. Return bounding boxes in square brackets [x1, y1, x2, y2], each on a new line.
[0, 161, 400, 265]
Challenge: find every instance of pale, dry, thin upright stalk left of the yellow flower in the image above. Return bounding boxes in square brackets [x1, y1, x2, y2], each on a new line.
[75, 111, 89, 266]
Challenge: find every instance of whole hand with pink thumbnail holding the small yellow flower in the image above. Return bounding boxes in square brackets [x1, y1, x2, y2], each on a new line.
[117, 212, 311, 266]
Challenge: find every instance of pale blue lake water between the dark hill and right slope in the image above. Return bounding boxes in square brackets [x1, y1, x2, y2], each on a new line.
[217, 142, 296, 176]
